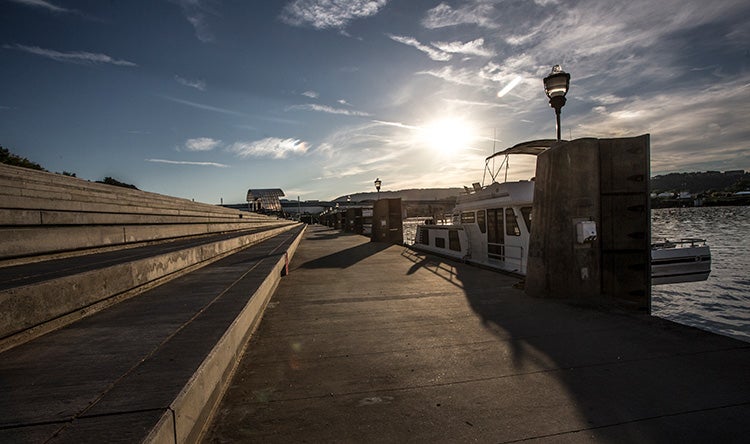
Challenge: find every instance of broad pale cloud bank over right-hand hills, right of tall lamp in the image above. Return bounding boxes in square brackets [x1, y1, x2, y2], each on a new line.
[568, 75, 750, 173]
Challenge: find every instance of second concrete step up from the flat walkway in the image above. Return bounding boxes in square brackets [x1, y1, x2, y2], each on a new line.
[0, 224, 299, 350]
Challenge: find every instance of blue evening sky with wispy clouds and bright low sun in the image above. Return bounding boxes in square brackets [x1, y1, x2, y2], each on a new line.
[0, 0, 750, 204]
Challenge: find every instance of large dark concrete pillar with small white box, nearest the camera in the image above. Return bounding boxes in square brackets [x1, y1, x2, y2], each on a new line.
[525, 135, 651, 307]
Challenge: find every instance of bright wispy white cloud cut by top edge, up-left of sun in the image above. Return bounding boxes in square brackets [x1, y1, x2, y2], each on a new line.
[280, 0, 387, 29]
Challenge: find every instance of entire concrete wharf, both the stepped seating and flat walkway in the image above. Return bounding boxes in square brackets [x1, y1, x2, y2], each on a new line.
[0, 155, 750, 444]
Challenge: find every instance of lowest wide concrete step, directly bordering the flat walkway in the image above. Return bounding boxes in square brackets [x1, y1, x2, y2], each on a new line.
[0, 225, 303, 443]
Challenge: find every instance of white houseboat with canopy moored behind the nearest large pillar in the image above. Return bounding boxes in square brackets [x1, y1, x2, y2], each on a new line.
[413, 140, 711, 285]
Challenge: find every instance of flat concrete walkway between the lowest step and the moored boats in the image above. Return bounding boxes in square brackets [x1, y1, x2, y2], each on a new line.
[203, 226, 750, 443]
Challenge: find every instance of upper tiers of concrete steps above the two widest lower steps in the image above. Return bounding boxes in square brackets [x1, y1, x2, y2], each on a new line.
[0, 165, 291, 265]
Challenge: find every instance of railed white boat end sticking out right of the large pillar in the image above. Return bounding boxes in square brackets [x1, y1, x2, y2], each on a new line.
[651, 239, 711, 285]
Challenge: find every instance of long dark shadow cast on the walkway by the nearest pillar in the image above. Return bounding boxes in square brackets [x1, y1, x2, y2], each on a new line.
[402, 245, 750, 442]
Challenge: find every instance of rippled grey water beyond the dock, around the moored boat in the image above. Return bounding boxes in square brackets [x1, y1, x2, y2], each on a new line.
[404, 207, 750, 342]
